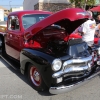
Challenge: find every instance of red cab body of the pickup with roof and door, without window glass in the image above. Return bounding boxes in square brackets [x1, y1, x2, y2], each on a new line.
[5, 10, 52, 60]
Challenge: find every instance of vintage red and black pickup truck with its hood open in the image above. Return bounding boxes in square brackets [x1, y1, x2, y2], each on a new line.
[0, 8, 100, 94]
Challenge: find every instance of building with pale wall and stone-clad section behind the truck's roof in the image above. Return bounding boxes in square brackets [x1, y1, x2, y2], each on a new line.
[23, 0, 71, 12]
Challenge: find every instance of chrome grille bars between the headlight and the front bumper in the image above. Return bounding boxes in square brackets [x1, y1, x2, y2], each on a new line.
[52, 56, 92, 78]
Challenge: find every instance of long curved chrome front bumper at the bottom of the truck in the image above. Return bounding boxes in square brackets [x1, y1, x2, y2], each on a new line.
[49, 71, 100, 94]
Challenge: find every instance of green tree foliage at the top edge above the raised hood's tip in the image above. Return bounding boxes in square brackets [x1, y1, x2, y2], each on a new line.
[70, 0, 95, 8]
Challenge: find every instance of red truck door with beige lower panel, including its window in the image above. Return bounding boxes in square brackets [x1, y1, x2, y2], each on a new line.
[5, 16, 23, 60]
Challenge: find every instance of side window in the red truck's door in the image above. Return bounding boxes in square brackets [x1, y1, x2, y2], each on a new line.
[8, 16, 20, 30]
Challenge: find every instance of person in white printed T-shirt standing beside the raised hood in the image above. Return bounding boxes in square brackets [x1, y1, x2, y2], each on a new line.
[79, 11, 96, 47]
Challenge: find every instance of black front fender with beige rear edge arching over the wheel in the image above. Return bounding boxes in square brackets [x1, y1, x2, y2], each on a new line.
[20, 49, 54, 87]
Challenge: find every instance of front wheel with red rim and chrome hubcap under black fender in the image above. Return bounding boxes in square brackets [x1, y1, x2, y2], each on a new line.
[28, 64, 46, 91]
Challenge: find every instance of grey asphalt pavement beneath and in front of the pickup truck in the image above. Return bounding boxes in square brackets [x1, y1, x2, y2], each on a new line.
[0, 58, 100, 100]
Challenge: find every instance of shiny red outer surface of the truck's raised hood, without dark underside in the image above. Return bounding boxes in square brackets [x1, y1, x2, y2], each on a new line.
[24, 8, 89, 39]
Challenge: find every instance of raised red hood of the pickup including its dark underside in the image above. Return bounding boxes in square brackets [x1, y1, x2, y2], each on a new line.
[24, 8, 90, 40]
